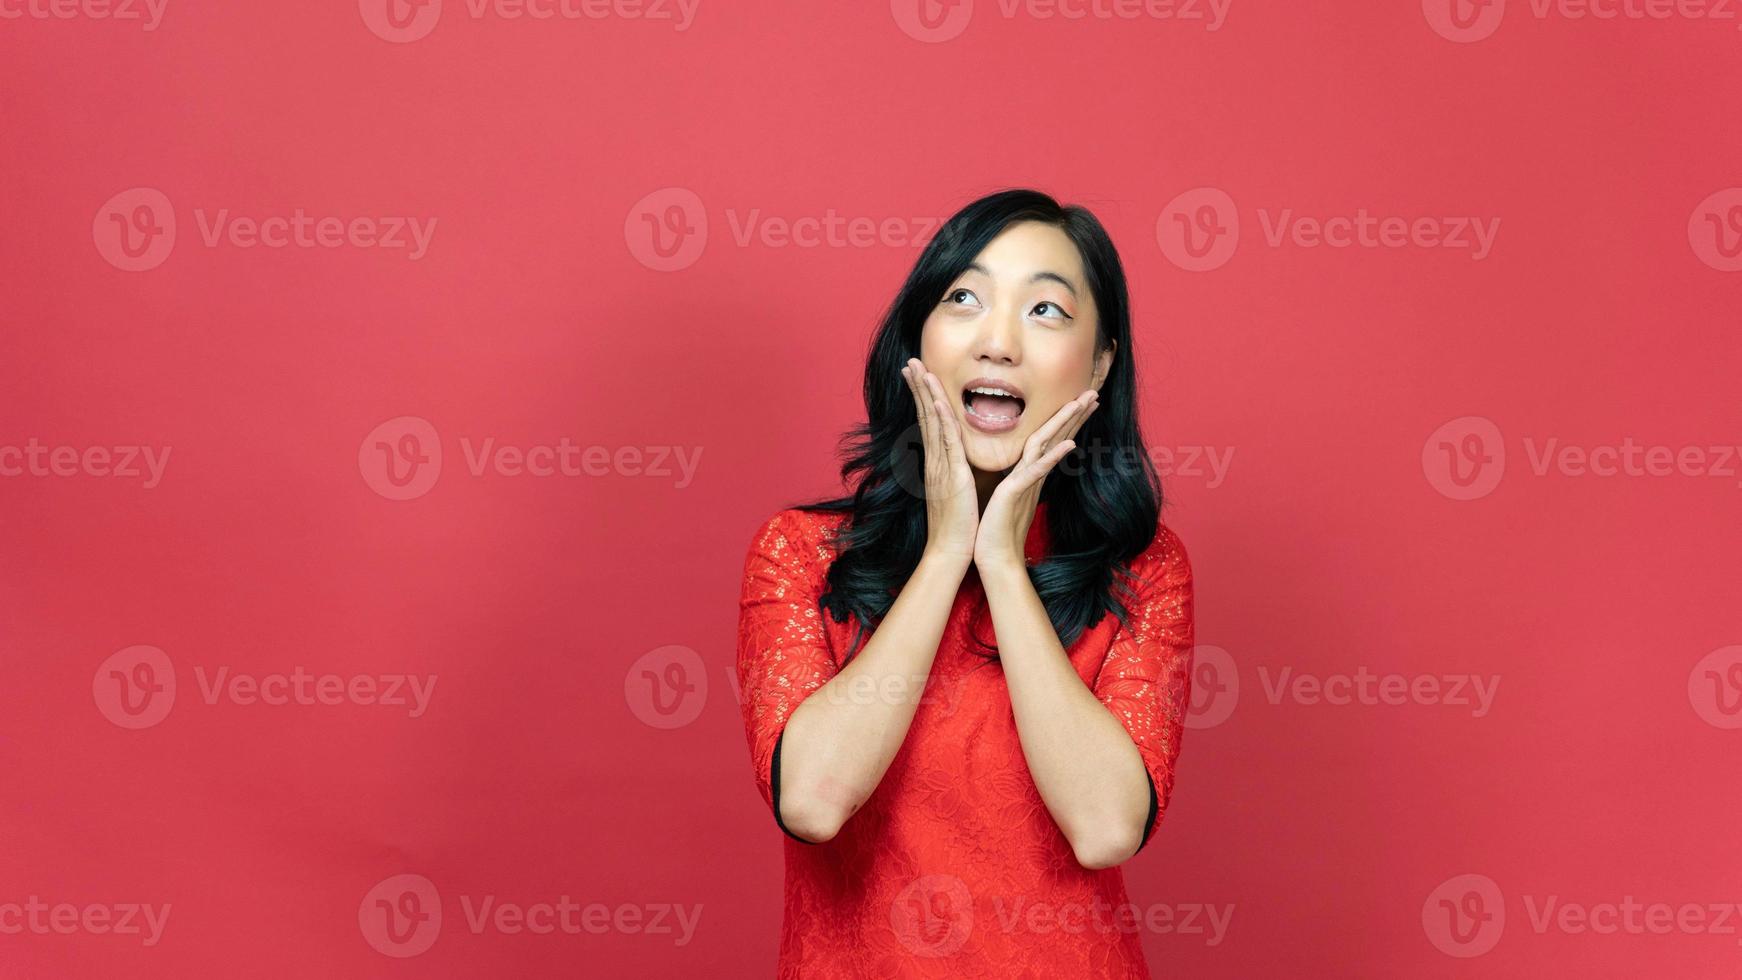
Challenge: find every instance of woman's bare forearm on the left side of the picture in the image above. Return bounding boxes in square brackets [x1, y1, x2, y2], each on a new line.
[779, 555, 969, 841]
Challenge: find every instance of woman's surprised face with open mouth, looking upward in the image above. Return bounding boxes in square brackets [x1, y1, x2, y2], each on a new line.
[920, 221, 1115, 475]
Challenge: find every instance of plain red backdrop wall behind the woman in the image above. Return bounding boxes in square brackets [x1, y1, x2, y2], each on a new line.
[0, 0, 1742, 977]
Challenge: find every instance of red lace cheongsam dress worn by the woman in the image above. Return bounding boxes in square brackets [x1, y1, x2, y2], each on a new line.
[737, 503, 1192, 980]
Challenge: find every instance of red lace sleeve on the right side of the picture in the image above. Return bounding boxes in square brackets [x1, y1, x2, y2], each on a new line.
[1094, 526, 1193, 851]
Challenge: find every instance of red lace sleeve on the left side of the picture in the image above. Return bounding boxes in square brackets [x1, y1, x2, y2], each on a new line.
[739, 510, 840, 844]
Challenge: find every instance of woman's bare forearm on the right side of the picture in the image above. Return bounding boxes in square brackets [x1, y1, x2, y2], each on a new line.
[981, 566, 1150, 869]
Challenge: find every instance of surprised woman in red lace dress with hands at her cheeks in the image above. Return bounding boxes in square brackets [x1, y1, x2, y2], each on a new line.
[737, 190, 1192, 978]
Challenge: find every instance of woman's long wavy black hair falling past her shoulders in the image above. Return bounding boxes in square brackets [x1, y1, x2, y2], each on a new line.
[794, 188, 1162, 663]
